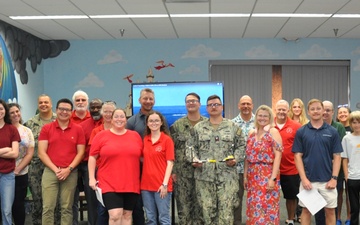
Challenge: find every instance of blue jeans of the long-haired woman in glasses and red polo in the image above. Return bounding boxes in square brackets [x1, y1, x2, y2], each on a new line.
[141, 191, 172, 225]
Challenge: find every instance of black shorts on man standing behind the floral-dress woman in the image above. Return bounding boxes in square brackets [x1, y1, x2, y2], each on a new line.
[280, 174, 300, 199]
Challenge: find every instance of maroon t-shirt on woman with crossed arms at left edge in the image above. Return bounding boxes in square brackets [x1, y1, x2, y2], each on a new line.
[0, 123, 21, 174]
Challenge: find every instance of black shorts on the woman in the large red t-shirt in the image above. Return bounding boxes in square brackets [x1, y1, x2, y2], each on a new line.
[103, 192, 140, 211]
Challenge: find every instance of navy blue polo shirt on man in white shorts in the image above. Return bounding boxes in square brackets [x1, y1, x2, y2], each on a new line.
[292, 122, 343, 182]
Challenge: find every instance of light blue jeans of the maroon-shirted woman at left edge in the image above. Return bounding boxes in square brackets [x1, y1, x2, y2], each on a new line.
[0, 172, 15, 225]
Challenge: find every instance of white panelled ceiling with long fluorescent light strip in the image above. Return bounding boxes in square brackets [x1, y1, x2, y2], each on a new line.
[0, 0, 360, 40]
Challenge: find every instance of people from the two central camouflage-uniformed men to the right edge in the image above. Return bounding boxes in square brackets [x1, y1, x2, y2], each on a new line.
[170, 93, 360, 225]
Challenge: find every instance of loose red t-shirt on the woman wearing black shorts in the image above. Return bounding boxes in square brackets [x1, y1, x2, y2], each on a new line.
[90, 130, 143, 194]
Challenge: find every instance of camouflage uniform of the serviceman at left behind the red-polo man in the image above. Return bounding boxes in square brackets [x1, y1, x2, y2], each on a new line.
[24, 113, 60, 225]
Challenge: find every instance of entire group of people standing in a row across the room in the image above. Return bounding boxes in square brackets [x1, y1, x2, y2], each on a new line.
[0, 88, 360, 225]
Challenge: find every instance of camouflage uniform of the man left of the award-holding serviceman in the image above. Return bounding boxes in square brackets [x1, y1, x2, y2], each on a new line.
[170, 116, 207, 225]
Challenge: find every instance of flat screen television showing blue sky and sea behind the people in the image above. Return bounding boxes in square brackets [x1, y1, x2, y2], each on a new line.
[131, 81, 224, 126]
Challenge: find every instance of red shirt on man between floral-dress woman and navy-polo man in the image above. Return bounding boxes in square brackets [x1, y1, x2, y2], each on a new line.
[275, 117, 301, 175]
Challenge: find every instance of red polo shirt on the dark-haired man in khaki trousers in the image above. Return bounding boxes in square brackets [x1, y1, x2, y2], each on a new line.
[39, 120, 85, 168]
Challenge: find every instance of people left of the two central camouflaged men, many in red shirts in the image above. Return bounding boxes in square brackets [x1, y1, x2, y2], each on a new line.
[0, 89, 174, 225]
